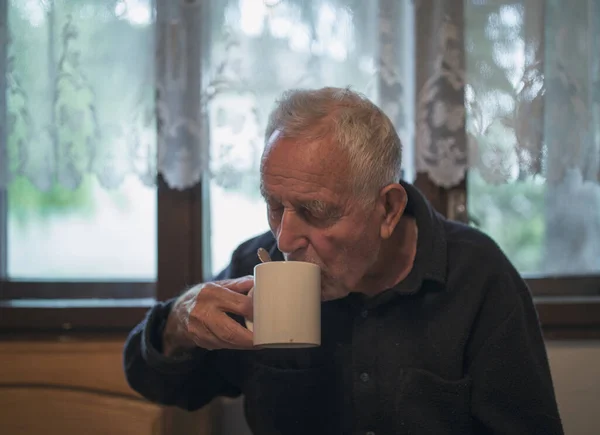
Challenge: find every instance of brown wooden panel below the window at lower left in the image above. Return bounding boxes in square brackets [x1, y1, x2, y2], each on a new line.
[0, 337, 210, 435]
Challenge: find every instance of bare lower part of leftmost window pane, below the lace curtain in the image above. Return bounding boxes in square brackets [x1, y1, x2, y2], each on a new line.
[7, 178, 156, 281]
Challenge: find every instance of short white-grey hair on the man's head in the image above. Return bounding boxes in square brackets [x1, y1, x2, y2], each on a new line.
[265, 87, 402, 203]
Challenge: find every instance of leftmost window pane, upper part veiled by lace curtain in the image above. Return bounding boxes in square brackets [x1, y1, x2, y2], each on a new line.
[0, 0, 157, 326]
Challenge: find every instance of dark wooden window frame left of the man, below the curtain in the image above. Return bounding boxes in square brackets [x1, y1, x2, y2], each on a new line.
[0, 177, 203, 333]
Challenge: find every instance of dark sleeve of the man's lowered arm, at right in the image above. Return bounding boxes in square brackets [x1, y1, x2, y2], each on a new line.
[468, 272, 564, 435]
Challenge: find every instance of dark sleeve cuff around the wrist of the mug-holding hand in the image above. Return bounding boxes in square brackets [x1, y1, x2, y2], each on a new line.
[141, 299, 209, 373]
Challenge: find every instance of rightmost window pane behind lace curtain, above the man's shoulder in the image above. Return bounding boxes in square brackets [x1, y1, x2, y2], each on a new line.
[465, 1, 600, 277]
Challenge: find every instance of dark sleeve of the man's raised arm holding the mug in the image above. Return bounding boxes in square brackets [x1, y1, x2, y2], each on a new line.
[123, 267, 241, 411]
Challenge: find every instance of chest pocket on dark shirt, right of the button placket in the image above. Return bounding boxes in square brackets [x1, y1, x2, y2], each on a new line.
[394, 369, 472, 434]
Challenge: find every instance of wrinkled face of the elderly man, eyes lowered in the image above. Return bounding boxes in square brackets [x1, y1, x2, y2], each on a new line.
[261, 138, 381, 300]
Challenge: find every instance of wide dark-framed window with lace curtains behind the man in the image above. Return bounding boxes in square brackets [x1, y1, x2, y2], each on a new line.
[0, 0, 600, 336]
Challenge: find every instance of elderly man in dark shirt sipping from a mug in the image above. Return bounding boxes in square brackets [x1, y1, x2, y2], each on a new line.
[124, 88, 562, 435]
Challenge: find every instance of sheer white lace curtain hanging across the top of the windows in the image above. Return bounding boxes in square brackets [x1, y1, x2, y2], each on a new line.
[0, 0, 600, 194]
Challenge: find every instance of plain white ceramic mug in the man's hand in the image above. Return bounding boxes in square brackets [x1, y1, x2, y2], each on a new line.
[246, 261, 321, 348]
